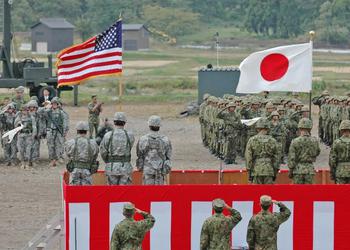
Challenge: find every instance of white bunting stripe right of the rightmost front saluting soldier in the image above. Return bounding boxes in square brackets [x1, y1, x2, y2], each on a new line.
[273, 201, 294, 250]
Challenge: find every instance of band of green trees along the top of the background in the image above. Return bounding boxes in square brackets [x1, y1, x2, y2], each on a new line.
[9, 0, 350, 44]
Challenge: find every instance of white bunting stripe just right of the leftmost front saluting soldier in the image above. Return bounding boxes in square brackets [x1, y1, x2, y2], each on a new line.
[150, 202, 171, 250]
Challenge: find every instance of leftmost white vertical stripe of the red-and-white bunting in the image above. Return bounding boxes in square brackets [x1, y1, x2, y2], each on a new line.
[69, 203, 90, 250]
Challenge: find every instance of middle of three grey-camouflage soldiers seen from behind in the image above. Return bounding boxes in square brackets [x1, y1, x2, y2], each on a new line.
[100, 112, 135, 185]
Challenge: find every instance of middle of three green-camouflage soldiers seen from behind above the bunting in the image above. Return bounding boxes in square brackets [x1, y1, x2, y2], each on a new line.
[288, 118, 320, 184]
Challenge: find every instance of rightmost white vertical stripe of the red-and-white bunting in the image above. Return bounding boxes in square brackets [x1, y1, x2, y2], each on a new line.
[313, 201, 334, 250]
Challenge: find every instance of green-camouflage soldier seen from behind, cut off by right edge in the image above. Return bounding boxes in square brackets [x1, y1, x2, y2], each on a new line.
[329, 120, 350, 184]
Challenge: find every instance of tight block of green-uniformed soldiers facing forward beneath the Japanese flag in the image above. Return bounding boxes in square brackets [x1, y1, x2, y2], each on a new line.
[199, 94, 310, 164]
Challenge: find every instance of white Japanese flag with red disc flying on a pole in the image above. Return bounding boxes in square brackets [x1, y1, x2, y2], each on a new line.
[236, 42, 312, 93]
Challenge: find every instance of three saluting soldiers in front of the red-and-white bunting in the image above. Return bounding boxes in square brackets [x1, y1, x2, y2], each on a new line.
[110, 195, 291, 250]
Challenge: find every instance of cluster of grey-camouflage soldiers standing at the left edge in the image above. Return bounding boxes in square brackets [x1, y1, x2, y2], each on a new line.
[0, 87, 69, 169]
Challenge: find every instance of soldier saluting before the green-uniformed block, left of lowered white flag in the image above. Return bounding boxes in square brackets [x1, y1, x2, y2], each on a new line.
[217, 102, 243, 164]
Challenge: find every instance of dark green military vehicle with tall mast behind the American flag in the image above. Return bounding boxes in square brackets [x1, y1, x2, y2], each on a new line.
[0, 0, 72, 97]
